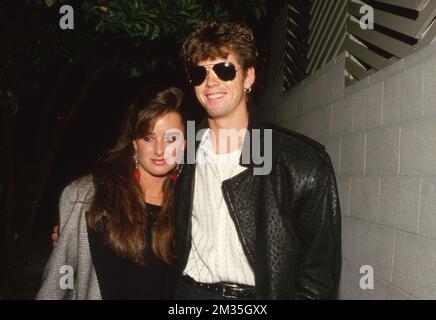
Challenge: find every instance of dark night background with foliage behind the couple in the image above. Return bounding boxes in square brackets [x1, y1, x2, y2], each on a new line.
[0, 0, 279, 299]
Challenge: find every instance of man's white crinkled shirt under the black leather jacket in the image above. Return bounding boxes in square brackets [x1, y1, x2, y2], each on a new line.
[184, 129, 255, 286]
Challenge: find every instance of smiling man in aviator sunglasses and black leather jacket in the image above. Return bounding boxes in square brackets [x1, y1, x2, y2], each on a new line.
[175, 22, 341, 299]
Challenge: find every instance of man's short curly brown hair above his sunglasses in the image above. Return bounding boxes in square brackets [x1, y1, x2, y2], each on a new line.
[181, 21, 258, 70]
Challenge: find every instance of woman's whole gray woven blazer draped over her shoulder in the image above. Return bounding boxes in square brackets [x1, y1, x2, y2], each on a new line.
[36, 175, 101, 300]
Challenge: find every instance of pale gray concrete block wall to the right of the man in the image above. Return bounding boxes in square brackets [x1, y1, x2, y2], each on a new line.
[264, 44, 436, 299]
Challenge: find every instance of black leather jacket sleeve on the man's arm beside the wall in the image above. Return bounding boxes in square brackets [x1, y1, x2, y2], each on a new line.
[295, 153, 342, 299]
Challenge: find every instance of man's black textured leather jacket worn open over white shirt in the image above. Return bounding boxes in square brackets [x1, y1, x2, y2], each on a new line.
[175, 116, 341, 299]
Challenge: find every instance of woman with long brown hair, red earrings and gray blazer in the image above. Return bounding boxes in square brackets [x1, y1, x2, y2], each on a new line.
[36, 87, 185, 299]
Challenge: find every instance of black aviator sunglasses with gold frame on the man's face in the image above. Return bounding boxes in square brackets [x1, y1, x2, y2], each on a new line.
[188, 61, 238, 86]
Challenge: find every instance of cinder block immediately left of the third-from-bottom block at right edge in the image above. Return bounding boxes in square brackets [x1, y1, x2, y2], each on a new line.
[366, 127, 400, 175]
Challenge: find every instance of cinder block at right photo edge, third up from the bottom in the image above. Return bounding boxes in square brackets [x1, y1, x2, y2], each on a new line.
[400, 118, 436, 176]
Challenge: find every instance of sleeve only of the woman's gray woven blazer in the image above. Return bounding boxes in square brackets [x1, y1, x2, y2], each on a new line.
[36, 181, 92, 300]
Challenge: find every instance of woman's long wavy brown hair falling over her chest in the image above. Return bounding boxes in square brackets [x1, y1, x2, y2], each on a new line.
[87, 87, 183, 265]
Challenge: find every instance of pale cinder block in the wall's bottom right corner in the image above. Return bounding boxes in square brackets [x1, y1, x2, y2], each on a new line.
[392, 231, 436, 300]
